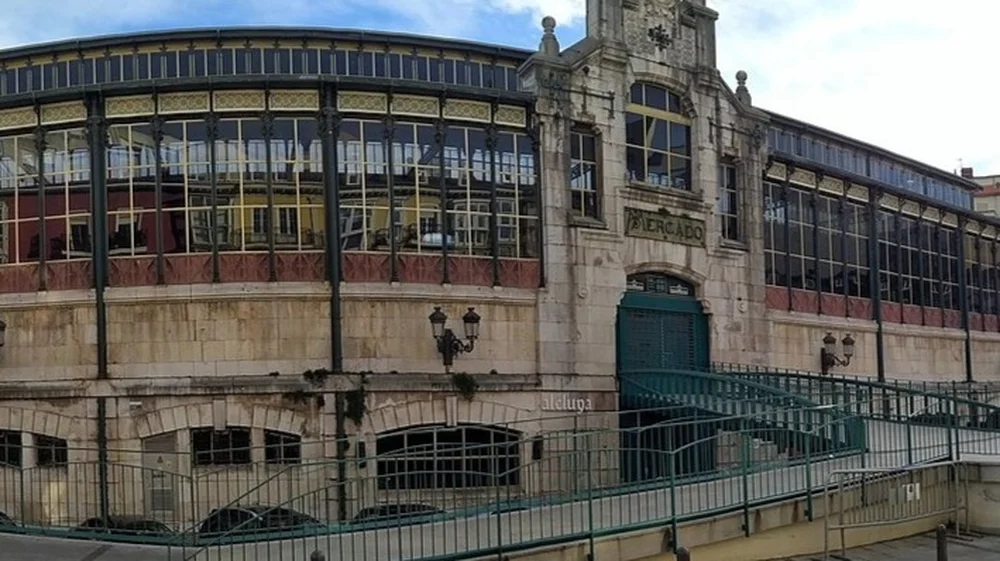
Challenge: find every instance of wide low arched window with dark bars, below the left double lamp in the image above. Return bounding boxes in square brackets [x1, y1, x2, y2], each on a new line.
[376, 425, 521, 489]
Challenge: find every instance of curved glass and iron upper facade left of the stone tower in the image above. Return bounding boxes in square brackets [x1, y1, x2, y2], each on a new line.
[0, 32, 541, 292]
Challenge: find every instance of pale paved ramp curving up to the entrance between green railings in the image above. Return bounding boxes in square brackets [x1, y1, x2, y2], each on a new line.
[0, 421, 1000, 561]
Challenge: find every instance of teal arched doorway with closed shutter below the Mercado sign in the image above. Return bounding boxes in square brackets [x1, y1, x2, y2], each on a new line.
[616, 273, 709, 373]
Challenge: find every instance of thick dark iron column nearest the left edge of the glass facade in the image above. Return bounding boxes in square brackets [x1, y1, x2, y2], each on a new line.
[87, 96, 108, 379]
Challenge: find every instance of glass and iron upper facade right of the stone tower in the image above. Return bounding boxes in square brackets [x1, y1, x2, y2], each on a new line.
[762, 112, 1000, 332]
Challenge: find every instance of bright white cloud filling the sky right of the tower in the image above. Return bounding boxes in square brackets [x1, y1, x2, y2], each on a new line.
[710, 0, 1000, 174]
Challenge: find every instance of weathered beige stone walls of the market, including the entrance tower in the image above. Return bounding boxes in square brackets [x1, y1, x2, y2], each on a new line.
[0, 0, 1000, 527]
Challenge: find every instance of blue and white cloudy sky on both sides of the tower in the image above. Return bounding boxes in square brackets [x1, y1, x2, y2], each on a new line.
[0, 0, 988, 175]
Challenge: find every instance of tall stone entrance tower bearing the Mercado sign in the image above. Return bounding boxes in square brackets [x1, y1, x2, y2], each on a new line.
[522, 0, 769, 376]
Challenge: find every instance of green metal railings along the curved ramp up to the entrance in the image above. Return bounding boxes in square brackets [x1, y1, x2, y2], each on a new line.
[0, 371, 1000, 561]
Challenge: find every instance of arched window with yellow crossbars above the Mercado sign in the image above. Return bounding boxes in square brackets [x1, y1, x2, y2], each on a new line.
[625, 83, 692, 191]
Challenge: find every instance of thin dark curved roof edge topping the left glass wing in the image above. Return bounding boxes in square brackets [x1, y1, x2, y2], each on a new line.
[0, 26, 533, 62]
